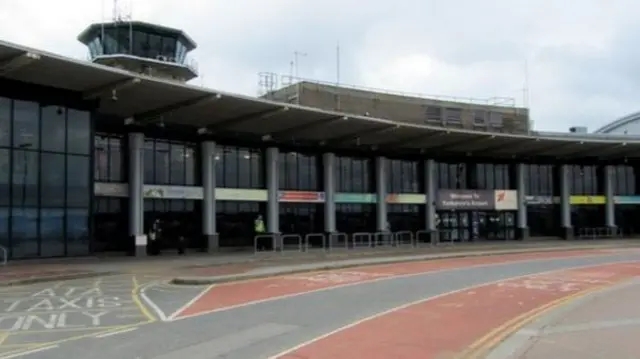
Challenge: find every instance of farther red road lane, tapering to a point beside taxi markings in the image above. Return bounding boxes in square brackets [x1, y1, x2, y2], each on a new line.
[173, 250, 611, 319]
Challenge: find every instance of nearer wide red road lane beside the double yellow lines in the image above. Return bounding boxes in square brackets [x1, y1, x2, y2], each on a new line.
[278, 263, 640, 359]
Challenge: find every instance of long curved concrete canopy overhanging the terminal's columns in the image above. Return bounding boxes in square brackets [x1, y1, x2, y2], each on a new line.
[0, 37, 640, 159]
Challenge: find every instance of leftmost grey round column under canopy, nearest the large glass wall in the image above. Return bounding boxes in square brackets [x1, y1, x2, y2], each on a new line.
[129, 132, 147, 257]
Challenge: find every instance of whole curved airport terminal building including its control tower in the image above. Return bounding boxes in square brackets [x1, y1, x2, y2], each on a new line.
[0, 22, 640, 259]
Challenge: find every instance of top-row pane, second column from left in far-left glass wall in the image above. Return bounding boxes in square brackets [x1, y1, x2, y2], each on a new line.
[13, 101, 40, 149]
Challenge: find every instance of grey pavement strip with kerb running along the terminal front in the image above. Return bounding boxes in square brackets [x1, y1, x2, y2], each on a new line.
[0, 240, 640, 287]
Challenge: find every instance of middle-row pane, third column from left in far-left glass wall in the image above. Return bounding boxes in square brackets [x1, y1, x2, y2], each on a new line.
[40, 153, 65, 207]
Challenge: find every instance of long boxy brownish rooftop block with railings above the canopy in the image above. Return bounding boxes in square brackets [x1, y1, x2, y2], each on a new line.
[260, 73, 531, 134]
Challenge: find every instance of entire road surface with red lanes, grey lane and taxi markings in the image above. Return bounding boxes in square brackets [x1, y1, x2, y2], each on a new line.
[0, 249, 640, 359]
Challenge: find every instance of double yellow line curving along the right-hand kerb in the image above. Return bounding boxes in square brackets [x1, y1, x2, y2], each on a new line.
[459, 280, 626, 359]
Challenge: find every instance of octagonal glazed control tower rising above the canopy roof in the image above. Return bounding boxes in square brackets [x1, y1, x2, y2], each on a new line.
[78, 19, 198, 82]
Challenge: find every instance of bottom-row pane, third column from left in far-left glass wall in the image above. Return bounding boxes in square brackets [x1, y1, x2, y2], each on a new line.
[40, 208, 64, 257]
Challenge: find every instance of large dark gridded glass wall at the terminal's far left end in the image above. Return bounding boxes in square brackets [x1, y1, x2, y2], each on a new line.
[0, 98, 93, 258]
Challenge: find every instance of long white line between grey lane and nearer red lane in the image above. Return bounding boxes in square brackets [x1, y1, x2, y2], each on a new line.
[267, 261, 636, 359]
